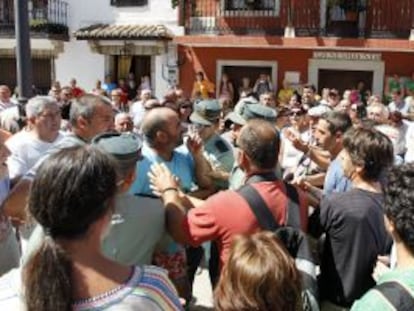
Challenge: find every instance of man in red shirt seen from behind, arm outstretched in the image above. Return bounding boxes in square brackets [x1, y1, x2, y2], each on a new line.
[150, 119, 308, 267]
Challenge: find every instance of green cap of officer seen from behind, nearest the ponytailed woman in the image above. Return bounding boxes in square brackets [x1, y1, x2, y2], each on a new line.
[91, 132, 142, 161]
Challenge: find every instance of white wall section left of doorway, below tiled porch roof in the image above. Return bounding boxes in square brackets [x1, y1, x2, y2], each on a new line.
[55, 41, 105, 91]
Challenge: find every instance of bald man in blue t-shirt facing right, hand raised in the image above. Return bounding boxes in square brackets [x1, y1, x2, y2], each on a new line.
[129, 107, 212, 195]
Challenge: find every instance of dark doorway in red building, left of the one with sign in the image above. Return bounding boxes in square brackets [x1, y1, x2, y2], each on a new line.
[223, 66, 274, 103]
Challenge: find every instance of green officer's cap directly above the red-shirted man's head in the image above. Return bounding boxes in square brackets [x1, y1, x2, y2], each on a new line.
[226, 104, 277, 125]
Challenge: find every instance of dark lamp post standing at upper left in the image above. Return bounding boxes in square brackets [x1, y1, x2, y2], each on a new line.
[14, 0, 33, 105]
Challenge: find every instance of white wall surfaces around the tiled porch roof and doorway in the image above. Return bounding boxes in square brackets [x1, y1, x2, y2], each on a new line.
[55, 0, 183, 92]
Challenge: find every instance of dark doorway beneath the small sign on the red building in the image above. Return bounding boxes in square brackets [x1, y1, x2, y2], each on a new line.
[318, 69, 374, 94]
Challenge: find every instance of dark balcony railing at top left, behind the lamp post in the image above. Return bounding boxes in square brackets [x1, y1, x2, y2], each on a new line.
[0, 0, 68, 39]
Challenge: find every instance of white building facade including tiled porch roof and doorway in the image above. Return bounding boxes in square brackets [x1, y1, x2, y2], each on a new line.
[54, 0, 183, 97]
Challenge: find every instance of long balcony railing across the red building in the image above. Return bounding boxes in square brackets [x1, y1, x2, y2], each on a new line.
[181, 0, 414, 38]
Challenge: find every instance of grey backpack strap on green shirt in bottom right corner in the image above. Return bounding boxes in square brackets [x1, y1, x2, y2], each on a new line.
[375, 281, 414, 311]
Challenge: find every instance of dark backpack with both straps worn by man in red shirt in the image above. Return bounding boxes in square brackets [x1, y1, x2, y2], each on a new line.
[238, 174, 319, 311]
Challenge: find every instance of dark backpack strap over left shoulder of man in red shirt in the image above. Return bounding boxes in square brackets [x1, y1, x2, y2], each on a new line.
[238, 184, 279, 231]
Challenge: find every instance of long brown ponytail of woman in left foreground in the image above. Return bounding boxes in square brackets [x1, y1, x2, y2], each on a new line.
[23, 235, 73, 311]
